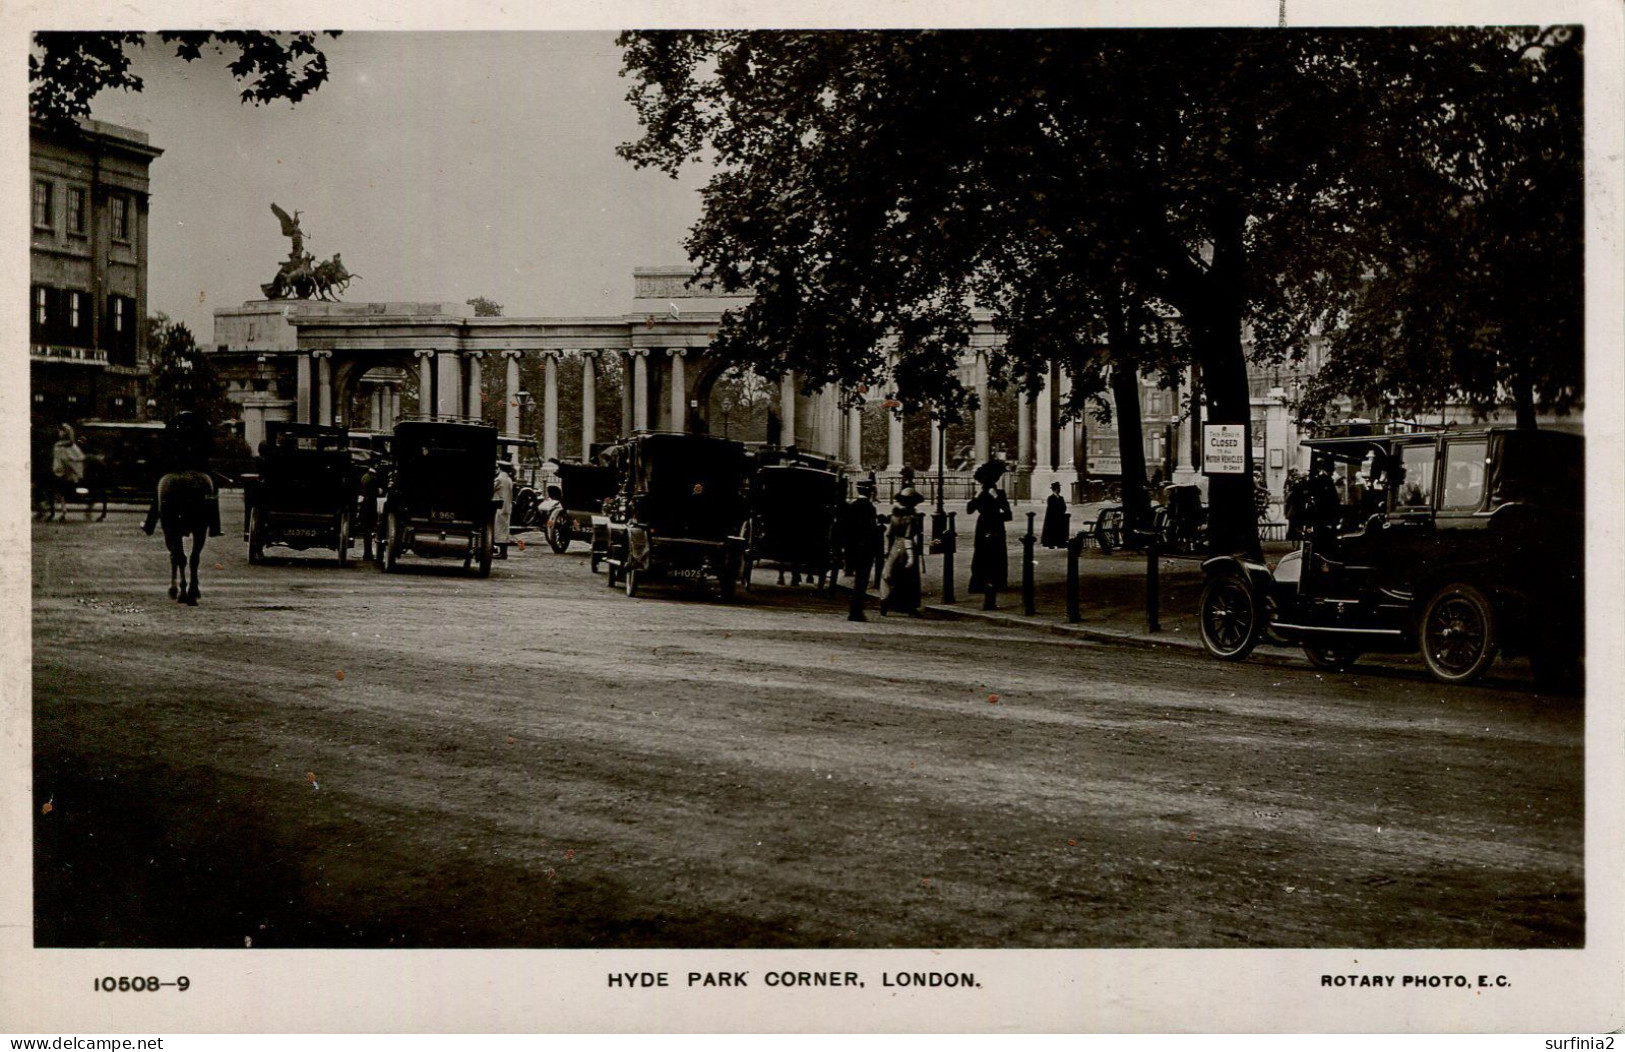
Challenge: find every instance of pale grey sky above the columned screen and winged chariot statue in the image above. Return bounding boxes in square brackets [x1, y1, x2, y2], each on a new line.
[79, 31, 705, 341]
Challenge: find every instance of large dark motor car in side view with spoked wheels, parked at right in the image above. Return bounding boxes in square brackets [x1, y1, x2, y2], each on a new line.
[1201, 426, 1586, 686]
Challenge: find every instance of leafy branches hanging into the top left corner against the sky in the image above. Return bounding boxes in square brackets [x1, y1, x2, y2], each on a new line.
[28, 31, 338, 128]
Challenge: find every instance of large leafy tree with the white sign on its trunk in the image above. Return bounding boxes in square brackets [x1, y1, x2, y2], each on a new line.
[621, 29, 1566, 553]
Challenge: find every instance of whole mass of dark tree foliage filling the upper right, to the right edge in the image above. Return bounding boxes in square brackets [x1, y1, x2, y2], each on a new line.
[621, 28, 1581, 551]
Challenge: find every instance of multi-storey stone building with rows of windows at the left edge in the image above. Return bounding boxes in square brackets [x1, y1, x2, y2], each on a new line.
[29, 120, 163, 433]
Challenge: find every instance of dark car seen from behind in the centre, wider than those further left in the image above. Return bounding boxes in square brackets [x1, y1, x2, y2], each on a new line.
[603, 434, 751, 602]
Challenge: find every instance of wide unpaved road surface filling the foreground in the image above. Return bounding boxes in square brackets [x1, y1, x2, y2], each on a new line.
[33, 497, 1584, 948]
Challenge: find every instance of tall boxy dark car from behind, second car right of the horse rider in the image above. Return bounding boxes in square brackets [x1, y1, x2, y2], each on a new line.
[377, 419, 499, 577]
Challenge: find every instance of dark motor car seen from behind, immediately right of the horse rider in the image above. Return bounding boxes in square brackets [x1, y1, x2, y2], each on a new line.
[242, 421, 356, 566]
